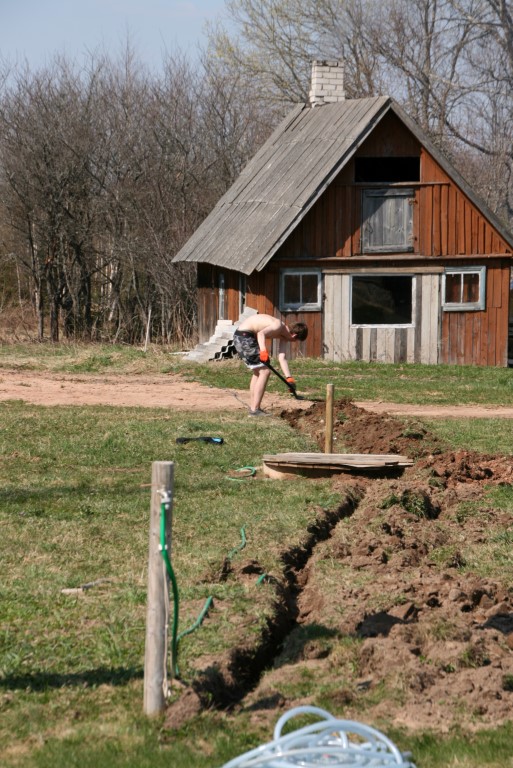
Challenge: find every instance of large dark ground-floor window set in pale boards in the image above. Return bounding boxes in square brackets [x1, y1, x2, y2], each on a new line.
[351, 275, 415, 326]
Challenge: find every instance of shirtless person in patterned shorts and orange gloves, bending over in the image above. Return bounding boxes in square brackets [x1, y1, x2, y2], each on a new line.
[233, 315, 308, 416]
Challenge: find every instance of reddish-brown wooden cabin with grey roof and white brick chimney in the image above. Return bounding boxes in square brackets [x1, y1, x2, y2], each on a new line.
[174, 61, 513, 366]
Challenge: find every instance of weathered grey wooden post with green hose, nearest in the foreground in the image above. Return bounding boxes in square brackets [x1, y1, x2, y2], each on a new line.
[143, 461, 174, 715]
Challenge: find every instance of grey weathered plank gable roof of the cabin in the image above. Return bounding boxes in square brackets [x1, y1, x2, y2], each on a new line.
[173, 96, 513, 275]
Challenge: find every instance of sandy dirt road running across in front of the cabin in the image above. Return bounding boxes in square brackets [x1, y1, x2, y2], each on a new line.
[0, 369, 513, 419]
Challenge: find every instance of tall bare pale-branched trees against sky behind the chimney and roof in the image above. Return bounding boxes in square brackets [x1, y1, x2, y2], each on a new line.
[206, 0, 513, 226]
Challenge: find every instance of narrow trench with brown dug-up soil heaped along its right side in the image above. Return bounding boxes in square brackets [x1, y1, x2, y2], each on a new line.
[166, 400, 513, 732]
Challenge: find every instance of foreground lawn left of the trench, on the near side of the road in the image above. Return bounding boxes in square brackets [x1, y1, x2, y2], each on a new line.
[0, 402, 334, 766]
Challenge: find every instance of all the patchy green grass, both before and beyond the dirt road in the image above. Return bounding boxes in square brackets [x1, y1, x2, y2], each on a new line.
[0, 345, 513, 768]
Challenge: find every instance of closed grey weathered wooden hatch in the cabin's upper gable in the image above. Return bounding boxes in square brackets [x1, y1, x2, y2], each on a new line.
[362, 188, 414, 253]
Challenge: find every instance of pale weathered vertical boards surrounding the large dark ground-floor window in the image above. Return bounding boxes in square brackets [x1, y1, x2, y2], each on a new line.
[324, 273, 440, 364]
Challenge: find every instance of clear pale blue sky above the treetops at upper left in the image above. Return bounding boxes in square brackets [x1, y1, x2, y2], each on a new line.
[0, 0, 229, 70]
